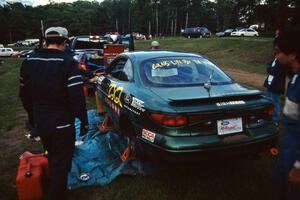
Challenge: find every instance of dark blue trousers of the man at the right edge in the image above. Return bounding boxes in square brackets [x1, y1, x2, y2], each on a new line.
[272, 117, 300, 200]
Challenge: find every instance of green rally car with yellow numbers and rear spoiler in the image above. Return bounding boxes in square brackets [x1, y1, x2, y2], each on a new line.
[97, 51, 278, 161]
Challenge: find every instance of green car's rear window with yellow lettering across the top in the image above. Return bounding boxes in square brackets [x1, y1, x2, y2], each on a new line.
[141, 57, 232, 87]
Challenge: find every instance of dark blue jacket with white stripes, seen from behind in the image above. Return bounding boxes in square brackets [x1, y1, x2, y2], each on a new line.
[19, 49, 88, 130]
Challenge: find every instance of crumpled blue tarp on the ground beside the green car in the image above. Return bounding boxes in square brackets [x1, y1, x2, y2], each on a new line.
[68, 110, 142, 189]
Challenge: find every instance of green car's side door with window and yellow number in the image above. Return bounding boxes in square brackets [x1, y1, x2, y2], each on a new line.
[101, 56, 134, 120]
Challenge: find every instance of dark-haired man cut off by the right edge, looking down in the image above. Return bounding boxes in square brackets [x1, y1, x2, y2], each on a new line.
[273, 30, 300, 200]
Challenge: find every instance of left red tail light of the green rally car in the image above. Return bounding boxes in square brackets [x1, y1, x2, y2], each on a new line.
[150, 113, 187, 127]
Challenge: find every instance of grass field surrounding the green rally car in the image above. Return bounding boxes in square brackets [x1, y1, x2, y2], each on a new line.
[0, 38, 274, 200]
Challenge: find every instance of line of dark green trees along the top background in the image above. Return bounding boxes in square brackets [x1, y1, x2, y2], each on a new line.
[0, 0, 300, 44]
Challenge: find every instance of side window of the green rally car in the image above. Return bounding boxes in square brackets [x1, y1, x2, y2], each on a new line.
[109, 58, 133, 81]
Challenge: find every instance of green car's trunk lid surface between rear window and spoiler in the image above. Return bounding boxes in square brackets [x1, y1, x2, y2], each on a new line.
[151, 83, 262, 103]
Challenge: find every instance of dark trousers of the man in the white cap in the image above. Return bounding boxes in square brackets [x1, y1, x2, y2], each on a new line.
[39, 126, 75, 200]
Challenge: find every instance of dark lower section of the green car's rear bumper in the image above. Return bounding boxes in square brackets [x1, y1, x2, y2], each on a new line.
[137, 128, 278, 163]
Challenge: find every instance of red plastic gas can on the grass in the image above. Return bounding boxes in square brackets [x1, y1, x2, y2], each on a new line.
[16, 152, 49, 200]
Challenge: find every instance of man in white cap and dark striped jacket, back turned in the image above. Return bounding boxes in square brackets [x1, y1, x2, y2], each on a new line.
[20, 27, 88, 200]
